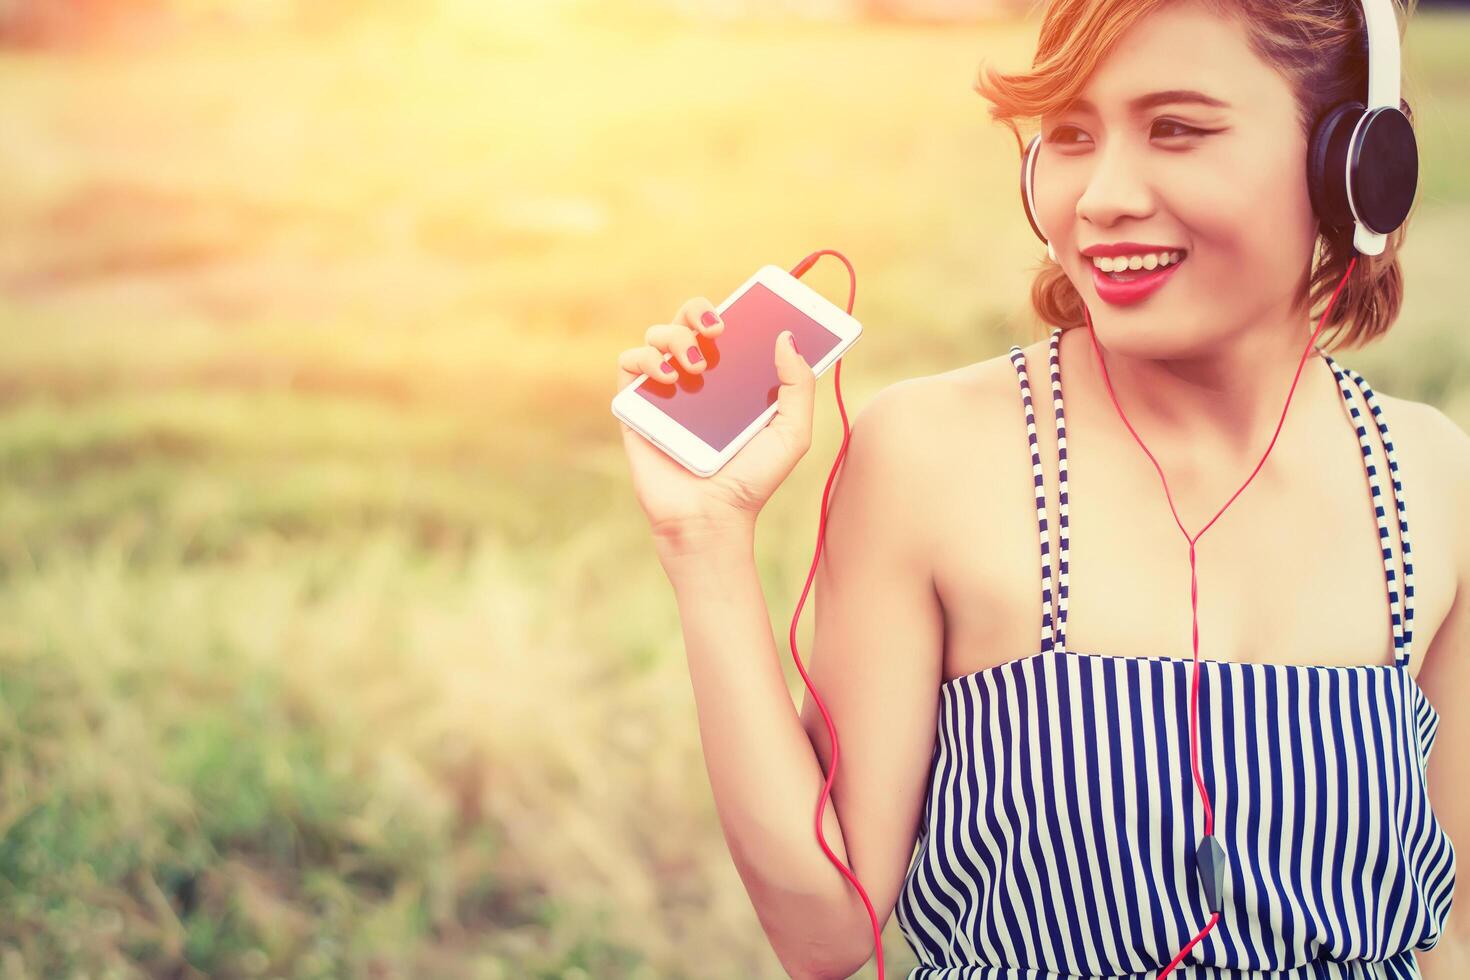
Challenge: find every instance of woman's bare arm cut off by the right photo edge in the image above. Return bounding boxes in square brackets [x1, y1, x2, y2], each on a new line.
[1417, 406, 1470, 957]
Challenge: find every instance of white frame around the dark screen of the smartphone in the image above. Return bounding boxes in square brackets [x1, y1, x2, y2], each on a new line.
[612, 264, 863, 476]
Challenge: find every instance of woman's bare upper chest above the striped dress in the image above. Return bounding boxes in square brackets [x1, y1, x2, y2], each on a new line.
[932, 382, 1455, 679]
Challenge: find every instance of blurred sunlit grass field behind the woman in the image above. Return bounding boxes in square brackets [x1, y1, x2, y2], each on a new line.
[0, 4, 1470, 979]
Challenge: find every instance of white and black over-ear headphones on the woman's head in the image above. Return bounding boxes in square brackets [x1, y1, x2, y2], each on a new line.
[1020, 0, 1419, 262]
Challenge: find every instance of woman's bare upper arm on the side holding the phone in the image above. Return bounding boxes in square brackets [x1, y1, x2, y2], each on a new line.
[801, 379, 944, 952]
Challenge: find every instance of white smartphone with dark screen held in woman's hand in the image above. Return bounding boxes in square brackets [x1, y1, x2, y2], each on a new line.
[613, 266, 863, 476]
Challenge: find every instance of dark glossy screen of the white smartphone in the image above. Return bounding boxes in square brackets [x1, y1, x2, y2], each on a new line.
[638, 282, 839, 451]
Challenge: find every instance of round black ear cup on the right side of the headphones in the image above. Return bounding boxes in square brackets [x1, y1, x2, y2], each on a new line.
[1307, 101, 1419, 235]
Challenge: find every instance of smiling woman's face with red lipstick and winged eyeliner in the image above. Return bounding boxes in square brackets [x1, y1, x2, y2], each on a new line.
[1035, 0, 1317, 359]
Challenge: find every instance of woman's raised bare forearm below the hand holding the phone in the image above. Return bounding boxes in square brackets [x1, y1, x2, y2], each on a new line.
[660, 527, 872, 977]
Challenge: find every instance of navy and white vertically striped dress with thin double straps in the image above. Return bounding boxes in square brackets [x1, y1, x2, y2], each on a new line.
[897, 328, 1455, 980]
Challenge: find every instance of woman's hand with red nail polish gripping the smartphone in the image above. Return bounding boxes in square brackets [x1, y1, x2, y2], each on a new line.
[617, 290, 816, 552]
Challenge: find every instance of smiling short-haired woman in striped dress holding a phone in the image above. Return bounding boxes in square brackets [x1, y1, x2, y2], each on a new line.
[619, 0, 1470, 980]
